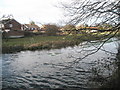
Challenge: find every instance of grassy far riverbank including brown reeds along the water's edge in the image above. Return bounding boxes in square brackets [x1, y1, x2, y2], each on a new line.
[2, 33, 120, 53]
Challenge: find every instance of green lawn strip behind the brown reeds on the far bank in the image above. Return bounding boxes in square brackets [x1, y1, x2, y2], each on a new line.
[2, 36, 73, 46]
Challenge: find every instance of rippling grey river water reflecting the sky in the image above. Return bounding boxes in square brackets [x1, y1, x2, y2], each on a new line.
[2, 38, 120, 90]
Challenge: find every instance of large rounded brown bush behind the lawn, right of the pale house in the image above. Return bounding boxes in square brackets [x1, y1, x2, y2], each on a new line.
[43, 24, 59, 36]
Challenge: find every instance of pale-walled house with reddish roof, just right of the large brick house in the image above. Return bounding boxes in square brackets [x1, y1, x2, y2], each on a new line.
[22, 24, 40, 33]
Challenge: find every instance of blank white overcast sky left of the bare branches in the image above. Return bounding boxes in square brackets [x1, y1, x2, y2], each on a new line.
[0, 0, 67, 24]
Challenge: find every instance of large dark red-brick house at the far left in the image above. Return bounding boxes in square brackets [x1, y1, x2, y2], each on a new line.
[0, 18, 24, 38]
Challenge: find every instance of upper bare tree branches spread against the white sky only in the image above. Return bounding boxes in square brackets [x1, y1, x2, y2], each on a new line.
[63, 0, 120, 26]
